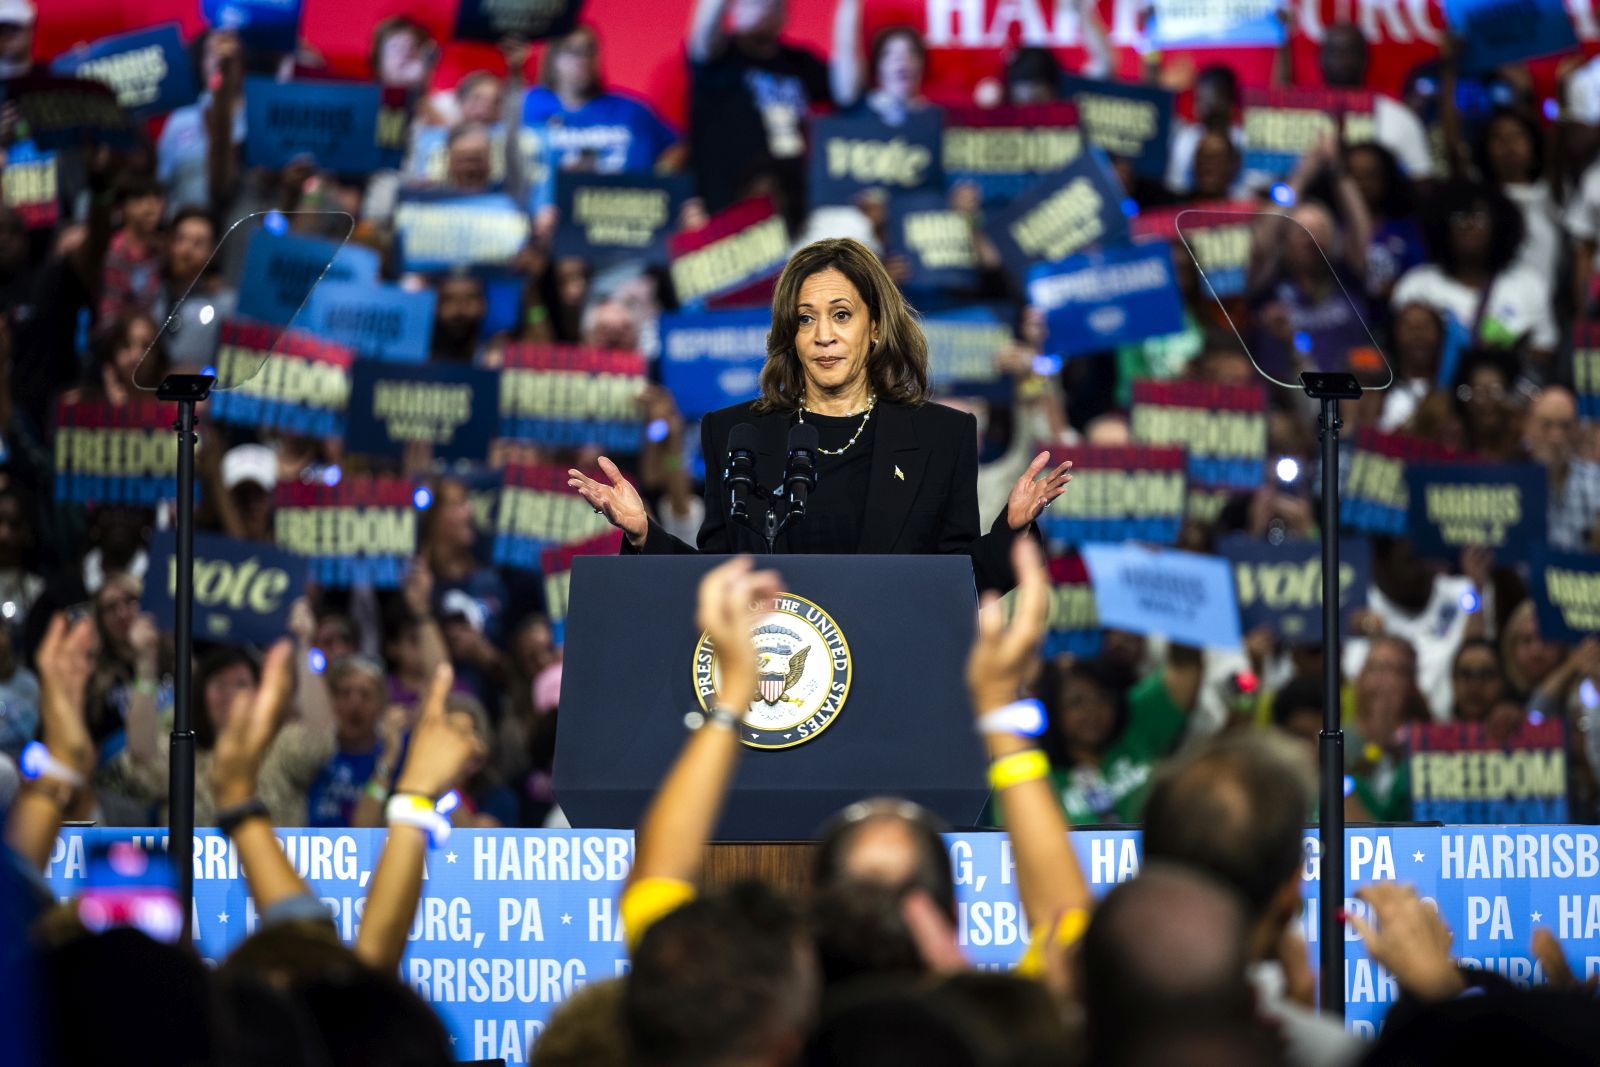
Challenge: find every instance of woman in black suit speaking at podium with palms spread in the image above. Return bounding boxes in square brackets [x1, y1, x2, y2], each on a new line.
[568, 238, 1072, 590]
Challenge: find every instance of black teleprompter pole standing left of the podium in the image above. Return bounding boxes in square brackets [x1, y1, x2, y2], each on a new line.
[155, 374, 214, 944]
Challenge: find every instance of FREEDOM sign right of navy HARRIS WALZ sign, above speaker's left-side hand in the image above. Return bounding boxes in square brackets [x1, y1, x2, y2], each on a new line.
[499, 344, 646, 453]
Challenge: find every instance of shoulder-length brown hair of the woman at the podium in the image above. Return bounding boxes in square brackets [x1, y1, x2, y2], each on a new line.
[755, 237, 928, 413]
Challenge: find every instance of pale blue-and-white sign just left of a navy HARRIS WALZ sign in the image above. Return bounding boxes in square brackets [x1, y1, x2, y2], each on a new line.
[395, 192, 528, 274]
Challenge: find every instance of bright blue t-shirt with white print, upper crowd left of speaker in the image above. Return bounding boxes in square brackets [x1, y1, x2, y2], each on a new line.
[522, 85, 678, 174]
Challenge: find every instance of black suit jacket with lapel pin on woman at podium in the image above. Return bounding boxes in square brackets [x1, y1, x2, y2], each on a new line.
[622, 402, 1038, 592]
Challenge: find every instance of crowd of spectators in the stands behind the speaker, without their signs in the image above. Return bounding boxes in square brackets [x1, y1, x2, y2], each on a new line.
[0, 0, 1600, 902]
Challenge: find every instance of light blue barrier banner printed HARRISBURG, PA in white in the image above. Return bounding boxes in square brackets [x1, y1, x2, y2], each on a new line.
[45, 825, 1600, 1043]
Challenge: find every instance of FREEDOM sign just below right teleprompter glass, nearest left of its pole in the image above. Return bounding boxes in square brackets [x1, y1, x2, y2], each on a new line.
[1131, 381, 1267, 490]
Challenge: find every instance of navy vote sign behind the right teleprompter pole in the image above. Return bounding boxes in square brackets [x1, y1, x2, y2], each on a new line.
[1216, 534, 1373, 645]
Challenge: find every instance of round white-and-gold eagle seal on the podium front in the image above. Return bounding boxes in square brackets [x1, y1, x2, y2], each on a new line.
[694, 593, 851, 749]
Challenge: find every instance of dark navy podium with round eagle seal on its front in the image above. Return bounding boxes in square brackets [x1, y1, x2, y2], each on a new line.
[554, 555, 989, 841]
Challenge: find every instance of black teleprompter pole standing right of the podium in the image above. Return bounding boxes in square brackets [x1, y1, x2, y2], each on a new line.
[1301, 371, 1362, 1019]
